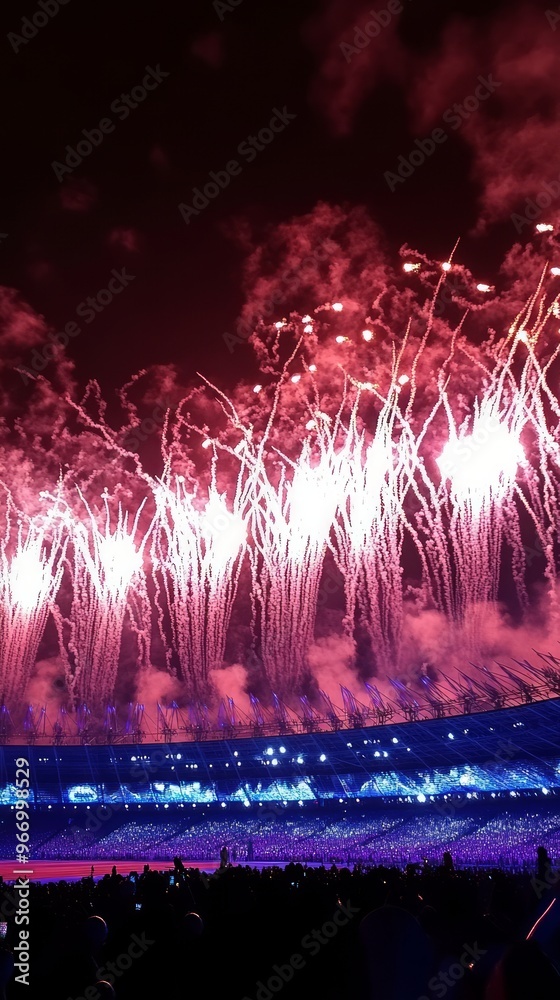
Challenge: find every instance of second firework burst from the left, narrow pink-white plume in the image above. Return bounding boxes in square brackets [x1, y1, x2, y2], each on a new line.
[63, 491, 146, 706]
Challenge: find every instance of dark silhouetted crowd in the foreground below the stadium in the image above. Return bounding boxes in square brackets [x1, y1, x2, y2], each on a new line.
[0, 845, 560, 1000]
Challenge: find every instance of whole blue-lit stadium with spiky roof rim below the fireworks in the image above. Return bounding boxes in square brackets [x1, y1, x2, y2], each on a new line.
[0, 669, 560, 874]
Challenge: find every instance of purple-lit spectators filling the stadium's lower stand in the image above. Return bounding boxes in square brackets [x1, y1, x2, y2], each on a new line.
[29, 799, 560, 869]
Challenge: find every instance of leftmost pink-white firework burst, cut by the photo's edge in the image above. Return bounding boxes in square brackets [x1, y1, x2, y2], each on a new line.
[0, 499, 66, 705]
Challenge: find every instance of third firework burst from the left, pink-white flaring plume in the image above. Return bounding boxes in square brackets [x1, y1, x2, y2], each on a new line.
[151, 462, 248, 700]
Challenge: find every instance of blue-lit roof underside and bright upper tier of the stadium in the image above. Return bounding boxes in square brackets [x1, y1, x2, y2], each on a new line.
[0, 698, 560, 809]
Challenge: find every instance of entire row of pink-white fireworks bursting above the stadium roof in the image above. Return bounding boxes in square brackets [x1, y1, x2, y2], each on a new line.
[0, 240, 560, 705]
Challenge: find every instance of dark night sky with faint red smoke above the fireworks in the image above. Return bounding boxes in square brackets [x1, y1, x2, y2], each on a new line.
[0, 0, 560, 387]
